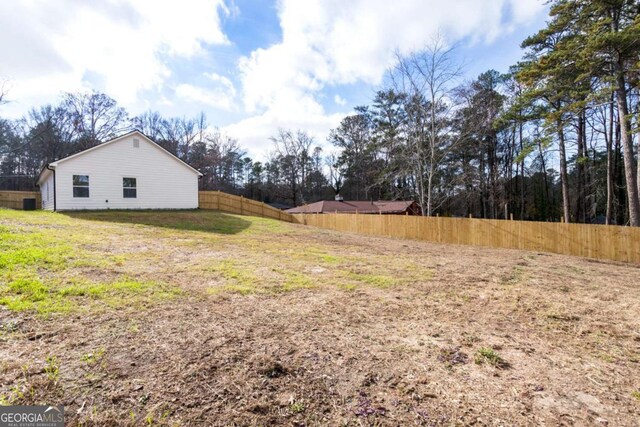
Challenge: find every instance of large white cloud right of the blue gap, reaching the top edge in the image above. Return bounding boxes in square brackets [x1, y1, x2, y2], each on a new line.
[228, 0, 545, 157]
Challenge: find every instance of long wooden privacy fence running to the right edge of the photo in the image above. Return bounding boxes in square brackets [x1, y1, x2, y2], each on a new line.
[293, 214, 640, 264]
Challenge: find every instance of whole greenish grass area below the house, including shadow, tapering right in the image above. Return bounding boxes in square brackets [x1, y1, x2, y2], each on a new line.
[0, 210, 440, 304]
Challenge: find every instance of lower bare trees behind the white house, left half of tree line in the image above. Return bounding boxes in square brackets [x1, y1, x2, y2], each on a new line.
[0, 92, 331, 206]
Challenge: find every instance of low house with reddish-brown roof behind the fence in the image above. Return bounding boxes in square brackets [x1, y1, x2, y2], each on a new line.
[285, 200, 420, 215]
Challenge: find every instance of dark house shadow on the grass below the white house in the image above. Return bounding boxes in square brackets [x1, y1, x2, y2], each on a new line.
[61, 209, 252, 234]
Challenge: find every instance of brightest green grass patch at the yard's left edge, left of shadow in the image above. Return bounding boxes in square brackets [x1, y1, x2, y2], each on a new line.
[0, 210, 188, 314]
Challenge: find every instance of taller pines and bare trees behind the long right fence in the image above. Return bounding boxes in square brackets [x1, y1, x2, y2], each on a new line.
[330, 0, 640, 226]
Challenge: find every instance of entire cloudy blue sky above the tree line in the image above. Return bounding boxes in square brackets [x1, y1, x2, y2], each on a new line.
[0, 0, 546, 157]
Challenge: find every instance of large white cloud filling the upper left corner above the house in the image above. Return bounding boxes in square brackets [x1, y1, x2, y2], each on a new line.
[0, 0, 229, 116]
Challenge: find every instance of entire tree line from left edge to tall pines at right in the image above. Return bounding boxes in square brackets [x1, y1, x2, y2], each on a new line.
[0, 0, 640, 226]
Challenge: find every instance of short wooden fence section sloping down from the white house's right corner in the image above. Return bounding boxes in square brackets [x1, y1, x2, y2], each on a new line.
[198, 191, 293, 222]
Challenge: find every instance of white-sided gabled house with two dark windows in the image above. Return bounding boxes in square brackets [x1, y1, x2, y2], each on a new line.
[37, 131, 202, 210]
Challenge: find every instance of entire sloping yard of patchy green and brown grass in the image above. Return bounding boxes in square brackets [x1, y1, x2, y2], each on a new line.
[0, 210, 640, 426]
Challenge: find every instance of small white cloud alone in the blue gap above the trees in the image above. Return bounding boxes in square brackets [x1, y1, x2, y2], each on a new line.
[175, 73, 237, 111]
